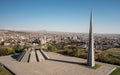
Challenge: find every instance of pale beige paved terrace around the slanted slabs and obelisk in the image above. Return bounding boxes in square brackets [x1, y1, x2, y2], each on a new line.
[0, 52, 116, 75]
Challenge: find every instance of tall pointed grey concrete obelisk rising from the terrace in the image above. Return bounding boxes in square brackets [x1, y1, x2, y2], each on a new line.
[87, 11, 95, 67]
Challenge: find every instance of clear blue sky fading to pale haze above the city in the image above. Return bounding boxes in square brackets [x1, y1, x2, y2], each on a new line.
[0, 0, 120, 34]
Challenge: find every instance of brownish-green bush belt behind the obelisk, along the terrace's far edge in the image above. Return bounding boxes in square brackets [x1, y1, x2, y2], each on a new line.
[57, 47, 120, 65]
